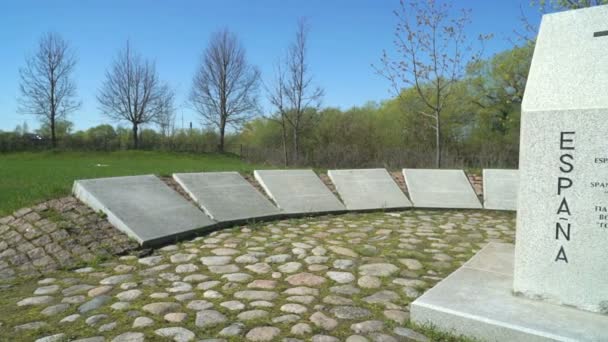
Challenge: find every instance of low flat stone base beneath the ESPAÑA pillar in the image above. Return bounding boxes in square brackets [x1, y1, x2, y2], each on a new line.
[410, 242, 608, 341]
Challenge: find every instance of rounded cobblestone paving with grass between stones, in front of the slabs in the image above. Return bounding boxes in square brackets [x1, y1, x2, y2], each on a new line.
[0, 210, 515, 342]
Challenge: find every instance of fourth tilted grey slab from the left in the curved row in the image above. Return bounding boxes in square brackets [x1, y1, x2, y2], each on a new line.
[327, 169, 412, 210]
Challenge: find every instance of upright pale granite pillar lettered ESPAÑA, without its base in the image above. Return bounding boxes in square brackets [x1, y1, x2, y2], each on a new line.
[514, 6, 608, 314]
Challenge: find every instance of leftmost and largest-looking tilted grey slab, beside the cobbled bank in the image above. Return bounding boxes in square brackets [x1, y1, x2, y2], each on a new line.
[73, 175, 215, 246]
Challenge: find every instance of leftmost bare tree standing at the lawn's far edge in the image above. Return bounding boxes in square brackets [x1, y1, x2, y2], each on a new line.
[19, 33, 80, 147]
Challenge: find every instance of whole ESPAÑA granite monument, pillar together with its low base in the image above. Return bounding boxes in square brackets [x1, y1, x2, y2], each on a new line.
[410, 5, 608, 341]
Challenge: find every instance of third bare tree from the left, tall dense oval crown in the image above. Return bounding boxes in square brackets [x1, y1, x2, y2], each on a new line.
[190, 29, 260, 152]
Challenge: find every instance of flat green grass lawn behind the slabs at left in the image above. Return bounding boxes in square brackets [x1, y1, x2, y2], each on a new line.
[0, 151, 262, 217]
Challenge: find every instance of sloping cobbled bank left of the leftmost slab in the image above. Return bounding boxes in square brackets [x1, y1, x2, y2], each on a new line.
[0, 197, 138, 280]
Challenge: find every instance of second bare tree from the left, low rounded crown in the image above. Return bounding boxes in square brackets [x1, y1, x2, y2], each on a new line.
[97, 42, 174, 149]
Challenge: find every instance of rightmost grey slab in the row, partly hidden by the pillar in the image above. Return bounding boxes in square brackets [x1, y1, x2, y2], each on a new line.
[483, 169, 519, 211]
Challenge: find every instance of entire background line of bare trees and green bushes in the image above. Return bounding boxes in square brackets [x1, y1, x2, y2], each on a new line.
[0, 0, 606, 167]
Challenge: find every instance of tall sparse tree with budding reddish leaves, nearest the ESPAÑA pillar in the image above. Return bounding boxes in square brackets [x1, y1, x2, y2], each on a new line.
[374, 0, 489, 168]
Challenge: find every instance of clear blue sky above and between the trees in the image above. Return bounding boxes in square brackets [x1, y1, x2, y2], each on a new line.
[0, 0, 540, 131]
